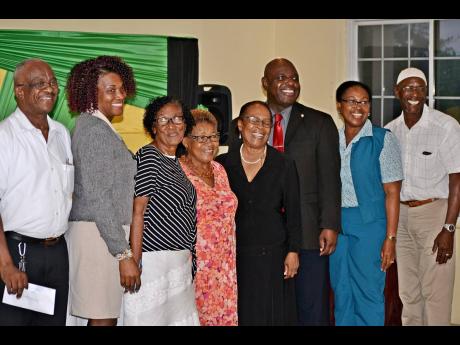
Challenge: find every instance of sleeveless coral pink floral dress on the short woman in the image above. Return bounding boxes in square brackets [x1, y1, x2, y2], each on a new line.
[181, 161, 238, 326]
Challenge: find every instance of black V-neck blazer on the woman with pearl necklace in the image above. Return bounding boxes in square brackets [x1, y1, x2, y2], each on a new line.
[216, 144, 301, 252]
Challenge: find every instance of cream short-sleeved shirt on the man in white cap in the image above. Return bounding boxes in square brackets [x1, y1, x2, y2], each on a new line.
[385, 105, 460, 201]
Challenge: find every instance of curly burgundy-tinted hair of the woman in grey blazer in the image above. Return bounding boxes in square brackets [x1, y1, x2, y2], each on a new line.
[66, 55, 136, 113]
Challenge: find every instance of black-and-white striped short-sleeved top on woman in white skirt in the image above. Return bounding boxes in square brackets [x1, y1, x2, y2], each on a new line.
[134, 145, 196, 276]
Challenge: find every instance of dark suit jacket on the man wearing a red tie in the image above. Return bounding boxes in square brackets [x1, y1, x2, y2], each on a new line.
[284, 102, 341, 249]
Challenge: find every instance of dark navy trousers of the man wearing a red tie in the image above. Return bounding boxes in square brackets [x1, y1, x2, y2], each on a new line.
[295, 249, 330, 326]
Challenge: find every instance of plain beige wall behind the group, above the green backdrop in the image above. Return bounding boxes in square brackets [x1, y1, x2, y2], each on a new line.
[0, 19, 347, 125]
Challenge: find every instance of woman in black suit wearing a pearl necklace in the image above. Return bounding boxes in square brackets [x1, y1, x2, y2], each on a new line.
[217, 101, 300, 325]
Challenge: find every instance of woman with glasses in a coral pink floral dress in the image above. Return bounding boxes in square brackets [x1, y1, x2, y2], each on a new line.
[180, 109, 238, 326]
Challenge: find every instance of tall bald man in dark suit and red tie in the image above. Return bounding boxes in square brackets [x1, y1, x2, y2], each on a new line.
[262, 58, 341, 325]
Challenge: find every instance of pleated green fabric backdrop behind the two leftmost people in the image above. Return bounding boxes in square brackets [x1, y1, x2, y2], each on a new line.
[0, 30, 168, 130]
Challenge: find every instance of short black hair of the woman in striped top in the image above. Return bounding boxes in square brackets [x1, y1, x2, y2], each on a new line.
[143, 96, 195, 139]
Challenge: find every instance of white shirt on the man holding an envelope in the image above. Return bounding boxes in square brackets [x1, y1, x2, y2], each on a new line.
[0, 108, 74, 238]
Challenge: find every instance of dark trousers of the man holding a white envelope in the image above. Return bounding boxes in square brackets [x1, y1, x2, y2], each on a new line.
[0, 232, 69, 326]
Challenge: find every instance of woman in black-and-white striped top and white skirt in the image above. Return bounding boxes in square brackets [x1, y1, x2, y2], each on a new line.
[124, 96, 199, 325]
